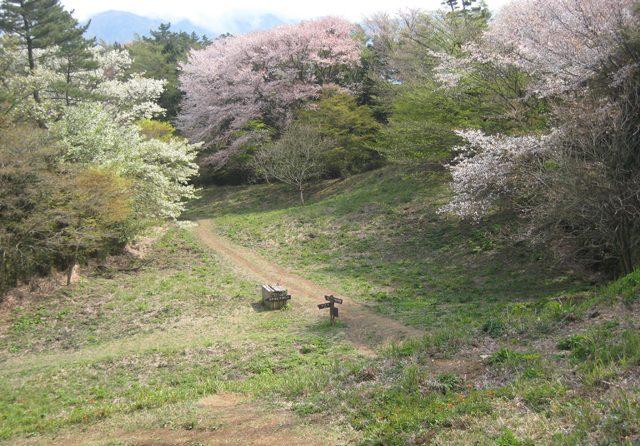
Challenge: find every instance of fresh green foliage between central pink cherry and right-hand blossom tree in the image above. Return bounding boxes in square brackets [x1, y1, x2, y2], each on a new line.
[379, 76, 545, 161]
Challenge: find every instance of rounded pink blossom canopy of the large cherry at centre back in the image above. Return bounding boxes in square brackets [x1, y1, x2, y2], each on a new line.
[178, 17, 362, 148]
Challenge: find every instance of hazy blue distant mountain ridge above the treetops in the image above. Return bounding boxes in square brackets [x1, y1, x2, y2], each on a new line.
[87, 11, 285, 43]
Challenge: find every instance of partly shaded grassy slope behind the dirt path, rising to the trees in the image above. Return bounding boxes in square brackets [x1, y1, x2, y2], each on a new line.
[188, 168, 584, 334]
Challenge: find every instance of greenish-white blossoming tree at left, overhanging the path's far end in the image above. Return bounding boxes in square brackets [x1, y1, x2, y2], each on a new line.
[51, 103, 199, 220]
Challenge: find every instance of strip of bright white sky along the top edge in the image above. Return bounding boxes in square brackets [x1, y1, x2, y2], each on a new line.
[61, 0, 509, 27]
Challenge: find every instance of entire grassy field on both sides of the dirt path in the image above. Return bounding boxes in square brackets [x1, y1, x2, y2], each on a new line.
[0, 168, 640, 445]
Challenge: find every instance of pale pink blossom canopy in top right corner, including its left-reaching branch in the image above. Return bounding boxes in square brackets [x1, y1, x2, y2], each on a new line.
[434, 0, 638, 96]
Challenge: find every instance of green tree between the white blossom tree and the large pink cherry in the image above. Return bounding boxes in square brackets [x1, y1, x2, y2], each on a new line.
[127, 23, 209, 120]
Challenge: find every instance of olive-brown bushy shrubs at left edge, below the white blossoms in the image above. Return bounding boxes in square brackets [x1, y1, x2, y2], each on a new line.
[0, 127, 132, 292]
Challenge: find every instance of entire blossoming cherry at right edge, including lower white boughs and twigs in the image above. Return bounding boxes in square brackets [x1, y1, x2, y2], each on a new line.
[442, 0, 640, 273]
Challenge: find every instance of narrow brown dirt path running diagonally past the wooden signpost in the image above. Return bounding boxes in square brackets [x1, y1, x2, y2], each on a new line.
[195, 220, 422, 355]
